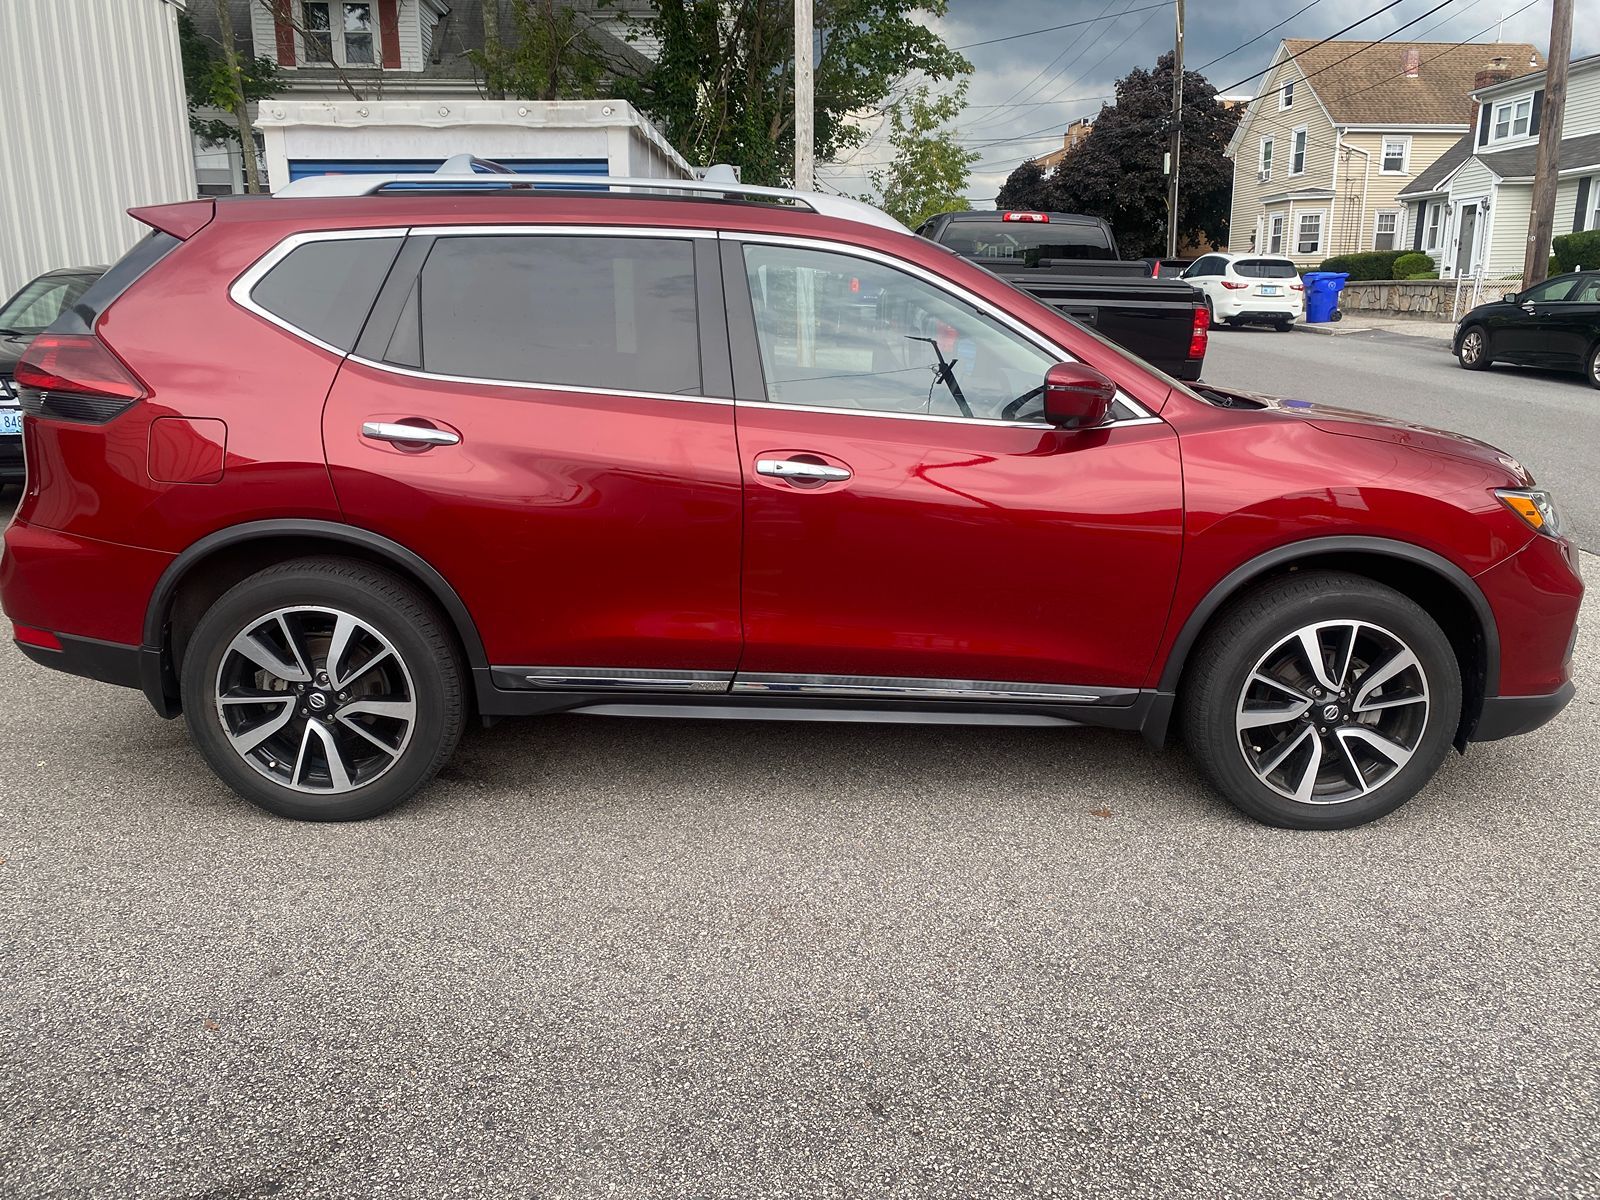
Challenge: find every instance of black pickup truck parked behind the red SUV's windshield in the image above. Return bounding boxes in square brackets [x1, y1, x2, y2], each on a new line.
[917, 211, 1208, 379]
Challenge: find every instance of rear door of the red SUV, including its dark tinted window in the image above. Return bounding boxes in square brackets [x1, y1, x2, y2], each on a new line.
[323, 226, 741, 691]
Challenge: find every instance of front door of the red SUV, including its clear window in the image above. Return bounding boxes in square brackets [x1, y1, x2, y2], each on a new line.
[723, 235, 1182, 698]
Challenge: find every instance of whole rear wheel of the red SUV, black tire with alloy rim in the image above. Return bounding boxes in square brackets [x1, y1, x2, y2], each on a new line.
[181, 558, 467, 821]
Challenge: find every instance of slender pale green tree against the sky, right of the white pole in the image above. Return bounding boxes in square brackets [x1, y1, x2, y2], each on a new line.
[862, 82, 978, 229]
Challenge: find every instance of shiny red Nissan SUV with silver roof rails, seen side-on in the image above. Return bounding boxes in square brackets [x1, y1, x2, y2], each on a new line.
[0, 167, 1582, 827]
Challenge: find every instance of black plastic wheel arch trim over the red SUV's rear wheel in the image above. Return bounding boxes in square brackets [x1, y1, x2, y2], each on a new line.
[144, 518, 490, 678]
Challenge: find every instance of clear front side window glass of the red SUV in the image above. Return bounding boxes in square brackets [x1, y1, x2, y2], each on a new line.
[744, 245, 1061, 419]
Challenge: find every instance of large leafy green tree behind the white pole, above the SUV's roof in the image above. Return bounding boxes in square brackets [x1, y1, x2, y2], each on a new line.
[619, 0, 971, 184]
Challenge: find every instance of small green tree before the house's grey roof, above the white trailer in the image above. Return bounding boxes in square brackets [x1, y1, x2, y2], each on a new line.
[467, 0, 613, 101]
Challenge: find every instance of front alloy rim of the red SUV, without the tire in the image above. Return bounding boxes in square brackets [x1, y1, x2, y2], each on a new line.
[1235, 621, 1429, 805]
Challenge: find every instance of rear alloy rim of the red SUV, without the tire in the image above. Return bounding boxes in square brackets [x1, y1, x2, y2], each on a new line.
[216, 606, 418, 795]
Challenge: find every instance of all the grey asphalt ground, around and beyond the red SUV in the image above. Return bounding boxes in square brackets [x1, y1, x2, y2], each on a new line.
[0, 333, 1600, 1200]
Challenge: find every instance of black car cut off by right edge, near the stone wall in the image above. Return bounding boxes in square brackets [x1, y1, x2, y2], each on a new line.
[1454, 270, 1600, 387]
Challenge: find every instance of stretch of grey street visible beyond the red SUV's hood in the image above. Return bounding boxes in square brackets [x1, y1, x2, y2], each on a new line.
[1205, 326, 1600, 550]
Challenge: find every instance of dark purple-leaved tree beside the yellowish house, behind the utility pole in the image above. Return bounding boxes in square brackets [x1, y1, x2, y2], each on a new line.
[1000, 54, 1238, 258]
